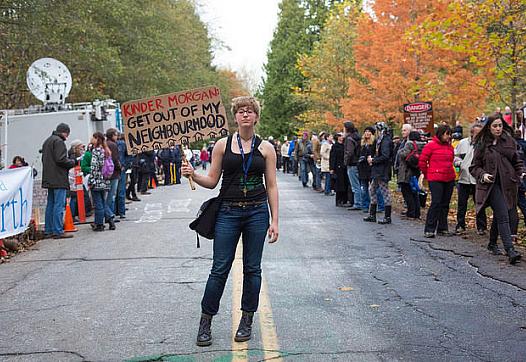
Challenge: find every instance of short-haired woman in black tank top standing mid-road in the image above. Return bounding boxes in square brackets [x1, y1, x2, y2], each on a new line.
[181, 97, 278, 346]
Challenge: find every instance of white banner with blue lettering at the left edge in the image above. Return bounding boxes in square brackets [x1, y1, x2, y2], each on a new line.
[0, 167, 33, 238]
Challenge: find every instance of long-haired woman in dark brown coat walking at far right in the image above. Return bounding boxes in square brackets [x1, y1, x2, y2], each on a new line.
[469, 116, 525, 264]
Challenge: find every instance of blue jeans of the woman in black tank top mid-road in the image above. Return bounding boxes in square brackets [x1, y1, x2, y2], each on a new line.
[201, 203, 269, 315]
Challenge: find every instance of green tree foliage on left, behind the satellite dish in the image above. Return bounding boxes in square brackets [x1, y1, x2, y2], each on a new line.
[0, 0, 241, 108]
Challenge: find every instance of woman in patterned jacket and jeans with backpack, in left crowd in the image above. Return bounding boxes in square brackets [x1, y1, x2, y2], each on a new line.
[88, 132, 115, 231]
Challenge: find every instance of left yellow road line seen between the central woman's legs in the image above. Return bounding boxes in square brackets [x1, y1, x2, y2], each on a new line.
[232, 239, 248, 362]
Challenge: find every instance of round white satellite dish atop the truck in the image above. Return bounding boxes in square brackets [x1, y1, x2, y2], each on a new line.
[26, 58, 72, 111]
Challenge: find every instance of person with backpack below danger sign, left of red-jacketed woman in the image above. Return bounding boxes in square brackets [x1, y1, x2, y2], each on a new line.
[397, 131, 426, 219]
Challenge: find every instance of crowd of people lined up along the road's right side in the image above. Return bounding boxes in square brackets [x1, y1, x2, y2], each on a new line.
[269, 116, 526, 264]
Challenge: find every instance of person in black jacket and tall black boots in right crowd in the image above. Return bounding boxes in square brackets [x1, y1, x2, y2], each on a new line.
[363, 122, 393, 224]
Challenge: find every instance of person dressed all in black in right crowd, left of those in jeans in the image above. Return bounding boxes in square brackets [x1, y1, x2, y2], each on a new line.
[329, 133, 349, 207]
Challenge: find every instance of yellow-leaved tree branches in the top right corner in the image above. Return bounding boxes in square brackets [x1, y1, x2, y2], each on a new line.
[415, 0, 526, 126]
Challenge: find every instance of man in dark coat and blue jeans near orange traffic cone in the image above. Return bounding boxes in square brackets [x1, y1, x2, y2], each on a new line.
[42, 123, 75, 239]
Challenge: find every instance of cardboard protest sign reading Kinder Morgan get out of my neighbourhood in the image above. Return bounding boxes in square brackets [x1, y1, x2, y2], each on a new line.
[121, 86, 228, 154]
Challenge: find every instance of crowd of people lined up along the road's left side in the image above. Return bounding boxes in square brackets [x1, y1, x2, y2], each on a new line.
[38, 123, 214, 239]
